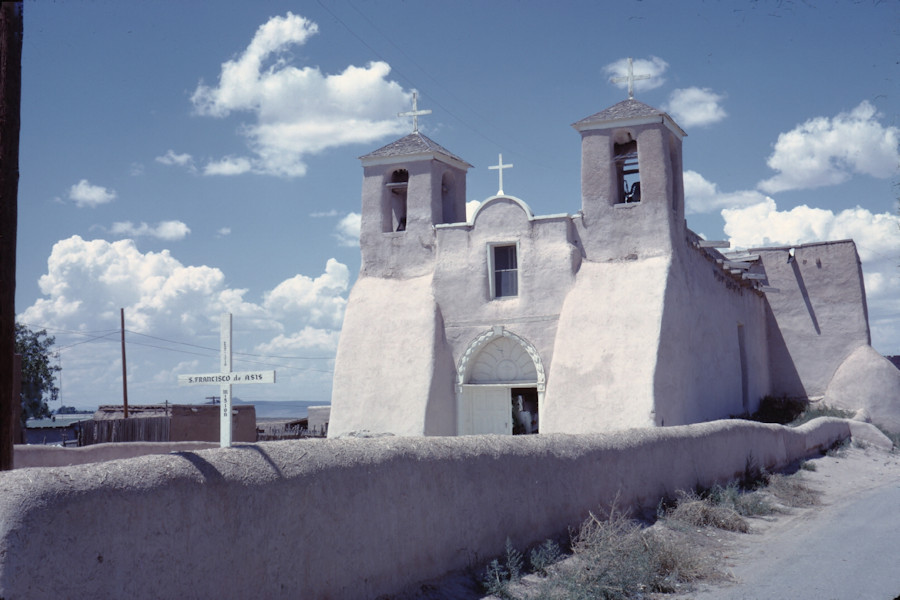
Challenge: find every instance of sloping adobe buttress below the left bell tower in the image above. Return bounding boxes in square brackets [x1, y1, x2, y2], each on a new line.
[328, 276, 456, 437]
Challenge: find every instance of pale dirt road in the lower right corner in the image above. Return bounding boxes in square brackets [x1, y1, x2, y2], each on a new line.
[666, 448, 900, 600]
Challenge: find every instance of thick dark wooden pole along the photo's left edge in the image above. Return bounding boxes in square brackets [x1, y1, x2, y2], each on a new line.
[0, 2, 23, 471]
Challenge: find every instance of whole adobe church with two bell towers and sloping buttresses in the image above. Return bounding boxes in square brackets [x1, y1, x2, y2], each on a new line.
[328, 86, 900, 437]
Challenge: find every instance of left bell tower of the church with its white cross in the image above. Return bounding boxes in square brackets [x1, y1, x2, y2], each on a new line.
[360, 90, 472, 278]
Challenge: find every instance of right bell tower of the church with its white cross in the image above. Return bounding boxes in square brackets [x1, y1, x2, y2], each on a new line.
[572, 59, 687, 260]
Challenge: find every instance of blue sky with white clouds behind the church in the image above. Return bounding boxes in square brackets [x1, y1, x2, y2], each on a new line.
[16, 0, 900, 409]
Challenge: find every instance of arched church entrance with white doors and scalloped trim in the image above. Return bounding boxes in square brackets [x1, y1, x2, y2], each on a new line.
[456, 327, 545, 435]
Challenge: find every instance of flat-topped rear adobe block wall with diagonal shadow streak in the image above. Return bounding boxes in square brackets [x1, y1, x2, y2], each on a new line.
[750, 240, 871, 397]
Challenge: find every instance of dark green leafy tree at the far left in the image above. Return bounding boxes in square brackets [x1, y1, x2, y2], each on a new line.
[16, 323, 62, 424]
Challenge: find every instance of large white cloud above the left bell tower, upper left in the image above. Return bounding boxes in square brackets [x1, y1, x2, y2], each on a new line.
[191, 12, 410, 177]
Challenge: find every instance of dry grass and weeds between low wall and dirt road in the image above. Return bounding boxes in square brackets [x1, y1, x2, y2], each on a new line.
[482, 474, 819, 600]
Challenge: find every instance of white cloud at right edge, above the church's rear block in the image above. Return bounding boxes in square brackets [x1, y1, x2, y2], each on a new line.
[758, 101, 900, 193]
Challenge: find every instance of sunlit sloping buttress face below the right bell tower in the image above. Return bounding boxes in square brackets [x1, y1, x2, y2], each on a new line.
[541, 256, 670, 433]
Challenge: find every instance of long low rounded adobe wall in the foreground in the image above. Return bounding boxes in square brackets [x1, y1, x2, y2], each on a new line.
[0, 419, 849, 598]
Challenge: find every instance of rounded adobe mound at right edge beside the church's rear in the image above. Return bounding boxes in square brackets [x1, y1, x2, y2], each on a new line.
[824, 346, 900, 433]
